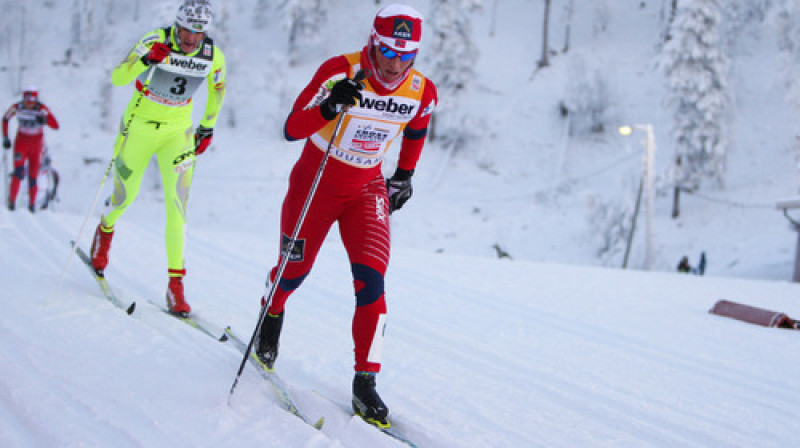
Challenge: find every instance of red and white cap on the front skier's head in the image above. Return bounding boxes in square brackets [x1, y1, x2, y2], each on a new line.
[370, 3, 422, 53]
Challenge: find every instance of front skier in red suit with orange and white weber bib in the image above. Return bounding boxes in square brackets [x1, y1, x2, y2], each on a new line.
[255, 4, 437, 426]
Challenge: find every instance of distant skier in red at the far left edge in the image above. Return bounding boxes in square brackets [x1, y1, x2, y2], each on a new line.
[3, 87, 58, 213]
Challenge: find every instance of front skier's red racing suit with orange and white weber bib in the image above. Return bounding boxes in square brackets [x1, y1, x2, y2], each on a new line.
[268, 47, 437, 372]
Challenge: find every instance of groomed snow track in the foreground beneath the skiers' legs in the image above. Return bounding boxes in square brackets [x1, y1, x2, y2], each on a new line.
[0, 211, 800, 447]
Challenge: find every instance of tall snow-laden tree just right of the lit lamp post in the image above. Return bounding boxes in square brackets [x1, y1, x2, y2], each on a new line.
[660, 0, 731, 189]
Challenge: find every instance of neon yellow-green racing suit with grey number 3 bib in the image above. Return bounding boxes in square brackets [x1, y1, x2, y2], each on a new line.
[101, 25, 225, 276]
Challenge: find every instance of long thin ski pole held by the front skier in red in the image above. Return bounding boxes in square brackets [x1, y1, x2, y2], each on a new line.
[228, 70, 367, 403]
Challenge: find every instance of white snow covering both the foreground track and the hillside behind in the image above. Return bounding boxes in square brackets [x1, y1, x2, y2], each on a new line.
[0, 0, 800, 448]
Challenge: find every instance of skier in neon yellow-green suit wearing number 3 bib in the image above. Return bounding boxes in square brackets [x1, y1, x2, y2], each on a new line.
[91, 0, 225, 315]
